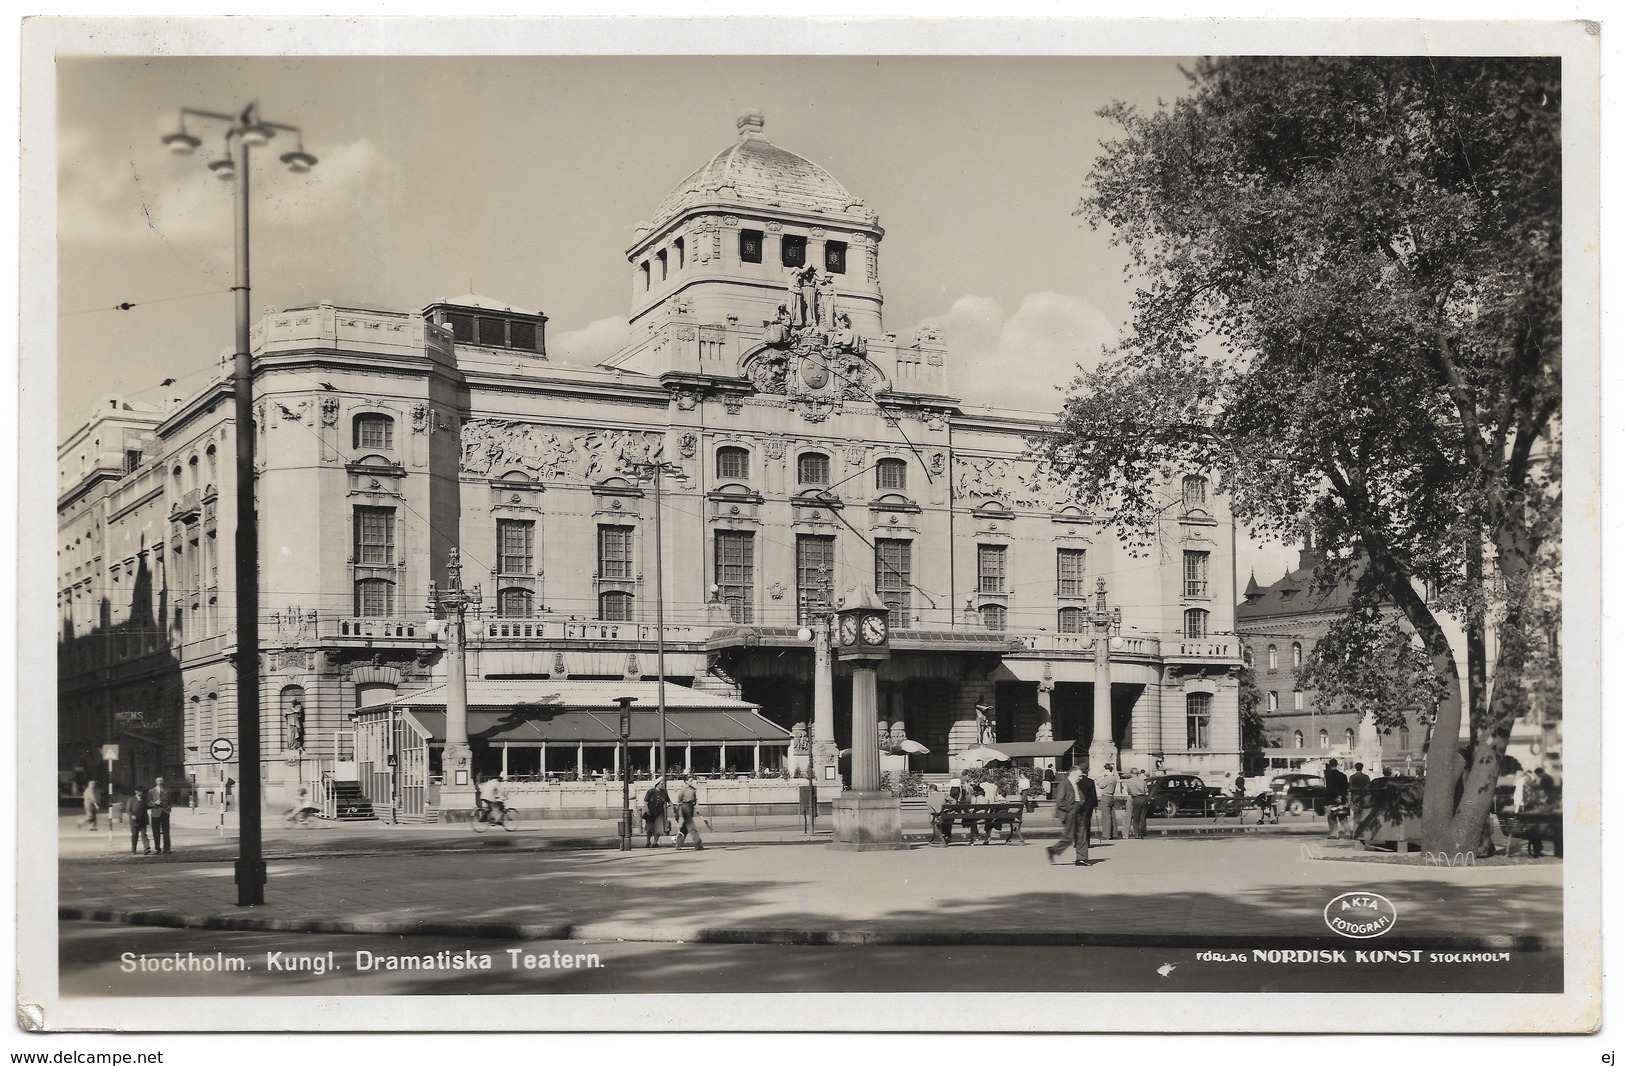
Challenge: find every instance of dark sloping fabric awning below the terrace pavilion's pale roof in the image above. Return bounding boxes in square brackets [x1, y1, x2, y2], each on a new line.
[405, 707, 790, 748]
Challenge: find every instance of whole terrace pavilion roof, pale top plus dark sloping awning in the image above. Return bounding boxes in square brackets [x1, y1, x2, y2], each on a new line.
[372, 681, 790, 748]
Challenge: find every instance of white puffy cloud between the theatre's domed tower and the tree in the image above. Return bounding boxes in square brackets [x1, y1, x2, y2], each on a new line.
[921, 293, 1118, 411]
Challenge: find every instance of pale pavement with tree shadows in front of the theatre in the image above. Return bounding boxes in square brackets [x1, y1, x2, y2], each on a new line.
[59, 819, 1563, 949]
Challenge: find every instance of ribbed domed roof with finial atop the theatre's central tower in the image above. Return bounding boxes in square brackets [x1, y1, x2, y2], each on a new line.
[650, 111, 873, 229]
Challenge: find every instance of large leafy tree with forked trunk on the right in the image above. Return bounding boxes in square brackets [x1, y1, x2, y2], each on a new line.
[1045, 57, 1562, 852]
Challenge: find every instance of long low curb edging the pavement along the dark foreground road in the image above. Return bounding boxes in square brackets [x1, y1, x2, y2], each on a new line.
[57, 907, 1562, 952]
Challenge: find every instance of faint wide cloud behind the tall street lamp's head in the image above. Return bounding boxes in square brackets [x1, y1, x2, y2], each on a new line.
[57, 127, 401, 247]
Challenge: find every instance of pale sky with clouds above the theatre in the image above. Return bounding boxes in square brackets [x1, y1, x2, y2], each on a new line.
[55, 45, 1410, 583]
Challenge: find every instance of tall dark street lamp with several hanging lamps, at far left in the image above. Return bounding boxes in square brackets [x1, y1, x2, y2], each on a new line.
[163, 104, 315, 907]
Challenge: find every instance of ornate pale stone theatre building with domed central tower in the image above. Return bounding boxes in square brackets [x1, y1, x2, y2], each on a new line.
[59, 114, 1242, 814]
